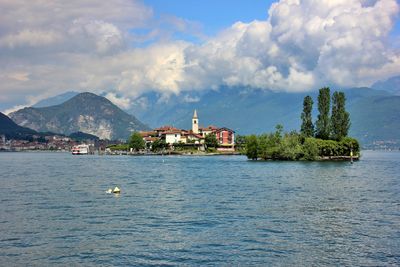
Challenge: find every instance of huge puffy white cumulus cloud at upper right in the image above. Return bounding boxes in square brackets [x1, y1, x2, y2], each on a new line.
[179, 0, 400, 91]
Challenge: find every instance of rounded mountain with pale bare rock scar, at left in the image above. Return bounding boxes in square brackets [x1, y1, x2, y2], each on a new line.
[9, 93, 148, 139]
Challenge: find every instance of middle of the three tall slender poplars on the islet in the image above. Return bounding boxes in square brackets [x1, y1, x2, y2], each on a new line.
[316, 87, 331, 140]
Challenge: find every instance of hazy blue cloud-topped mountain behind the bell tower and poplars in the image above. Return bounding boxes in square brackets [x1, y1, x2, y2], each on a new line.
[132, 88, 400, 147]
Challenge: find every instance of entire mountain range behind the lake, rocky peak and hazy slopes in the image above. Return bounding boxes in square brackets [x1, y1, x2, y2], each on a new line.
[6, 76, 400, 145]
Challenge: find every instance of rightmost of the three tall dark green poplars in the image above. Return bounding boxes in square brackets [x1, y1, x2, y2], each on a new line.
[331, 92, 350, 141]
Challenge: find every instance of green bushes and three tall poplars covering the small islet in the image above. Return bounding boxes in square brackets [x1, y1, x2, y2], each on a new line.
[243, 87, 360, 160]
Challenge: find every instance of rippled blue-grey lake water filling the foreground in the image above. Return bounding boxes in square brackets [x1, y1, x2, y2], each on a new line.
[0, 152, 400, 266]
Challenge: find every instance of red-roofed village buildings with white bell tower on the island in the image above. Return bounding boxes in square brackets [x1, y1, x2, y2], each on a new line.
[140, 110, 235, 151]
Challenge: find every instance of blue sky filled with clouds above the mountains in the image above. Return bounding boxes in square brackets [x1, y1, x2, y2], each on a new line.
[0, 0, 400, 113]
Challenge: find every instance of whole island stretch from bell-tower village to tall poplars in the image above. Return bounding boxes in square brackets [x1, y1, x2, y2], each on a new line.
[106, 87, 360, 161]
